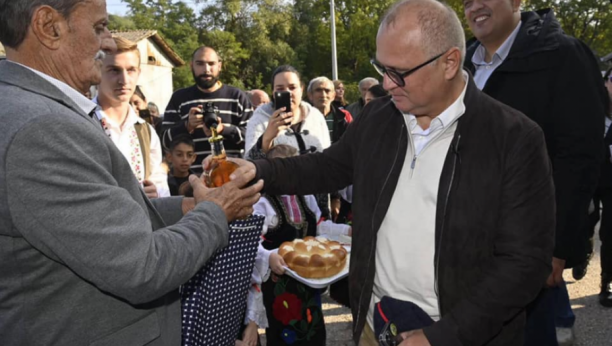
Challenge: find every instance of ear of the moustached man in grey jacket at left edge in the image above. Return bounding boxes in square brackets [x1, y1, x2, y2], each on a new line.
[30, 5, 69, 50]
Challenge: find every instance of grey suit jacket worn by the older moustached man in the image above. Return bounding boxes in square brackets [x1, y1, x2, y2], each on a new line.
[0, 62, 228, 346]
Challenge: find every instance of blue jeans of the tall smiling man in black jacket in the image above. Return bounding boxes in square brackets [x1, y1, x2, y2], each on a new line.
[525, 282, 576, 346]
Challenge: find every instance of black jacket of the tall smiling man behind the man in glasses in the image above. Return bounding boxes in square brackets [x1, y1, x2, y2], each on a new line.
[465, 9, 605, 267]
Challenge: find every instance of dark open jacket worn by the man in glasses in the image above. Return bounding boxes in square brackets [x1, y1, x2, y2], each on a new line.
[255, 79, 555, 346]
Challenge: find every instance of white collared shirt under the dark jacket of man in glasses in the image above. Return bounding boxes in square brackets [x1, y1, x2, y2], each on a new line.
[367, 72, 469, 327]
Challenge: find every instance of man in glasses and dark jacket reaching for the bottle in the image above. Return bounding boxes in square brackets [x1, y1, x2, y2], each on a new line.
[219, 0, 555, 346]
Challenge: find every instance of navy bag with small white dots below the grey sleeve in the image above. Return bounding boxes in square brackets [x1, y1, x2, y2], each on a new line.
[181, 215, 265, 346]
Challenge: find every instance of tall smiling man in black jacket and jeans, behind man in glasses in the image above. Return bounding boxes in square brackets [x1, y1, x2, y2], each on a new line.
[464, 0, 604, 345]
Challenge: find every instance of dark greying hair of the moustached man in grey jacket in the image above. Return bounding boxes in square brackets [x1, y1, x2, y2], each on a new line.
[0, 0, 83, 49]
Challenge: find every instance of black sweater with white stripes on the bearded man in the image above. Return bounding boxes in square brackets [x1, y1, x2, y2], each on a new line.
[162, 85, 253, 174]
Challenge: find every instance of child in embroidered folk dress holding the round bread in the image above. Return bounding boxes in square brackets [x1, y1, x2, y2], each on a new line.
[243, 145, 352, 346]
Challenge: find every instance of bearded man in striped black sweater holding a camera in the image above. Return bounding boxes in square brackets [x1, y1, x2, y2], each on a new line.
[162, 46, 253, 173]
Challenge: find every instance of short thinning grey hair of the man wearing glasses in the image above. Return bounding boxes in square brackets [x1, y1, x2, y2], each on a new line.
[380, 0, 465, 66]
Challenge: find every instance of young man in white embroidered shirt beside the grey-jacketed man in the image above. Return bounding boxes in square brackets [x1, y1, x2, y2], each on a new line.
[94, 37, 170, 198]
